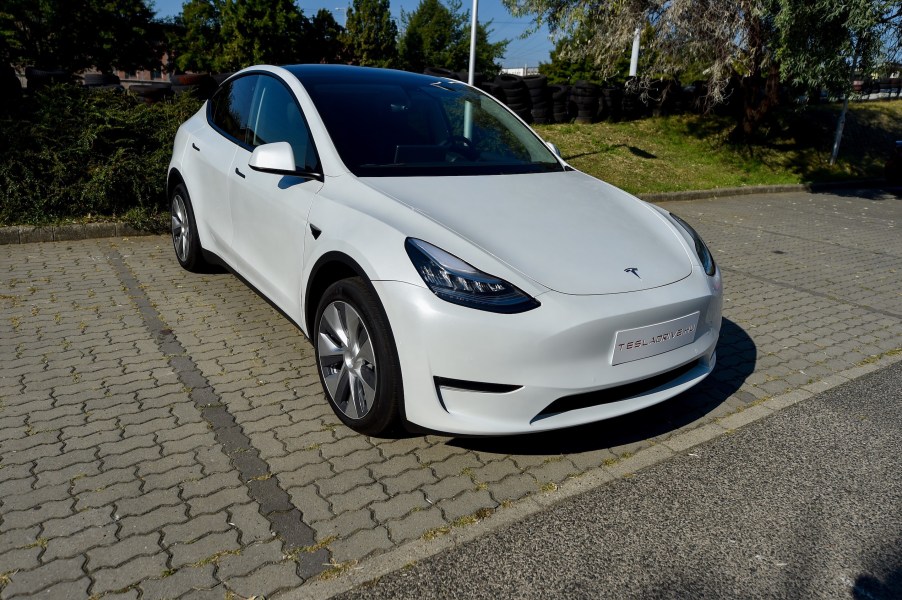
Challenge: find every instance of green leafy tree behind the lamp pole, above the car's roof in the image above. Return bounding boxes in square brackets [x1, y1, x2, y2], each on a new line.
[399, 0, 508, 75]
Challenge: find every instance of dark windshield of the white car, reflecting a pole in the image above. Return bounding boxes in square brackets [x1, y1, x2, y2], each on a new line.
[305, 77, 563, 177]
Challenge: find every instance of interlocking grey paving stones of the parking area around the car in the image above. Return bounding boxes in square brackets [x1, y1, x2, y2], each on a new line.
[0, 192, 902, 599]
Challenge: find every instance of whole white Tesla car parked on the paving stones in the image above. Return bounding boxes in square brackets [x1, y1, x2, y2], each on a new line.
[168, 65, 722, 435]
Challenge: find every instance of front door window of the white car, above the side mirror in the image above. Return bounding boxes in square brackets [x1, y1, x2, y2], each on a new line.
[247, 75, 319, 171]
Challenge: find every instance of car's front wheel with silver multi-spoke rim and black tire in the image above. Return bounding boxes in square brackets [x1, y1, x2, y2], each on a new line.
[313, 277, 404, 436]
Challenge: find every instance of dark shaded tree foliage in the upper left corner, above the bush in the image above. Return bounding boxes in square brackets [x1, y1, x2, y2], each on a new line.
[0, 0, 162, 72]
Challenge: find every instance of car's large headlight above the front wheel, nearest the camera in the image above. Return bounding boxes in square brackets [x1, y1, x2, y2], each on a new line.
[404, 238, 539, 314]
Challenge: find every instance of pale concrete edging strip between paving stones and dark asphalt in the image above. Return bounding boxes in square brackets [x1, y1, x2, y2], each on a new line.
[279, 354, 902, 600]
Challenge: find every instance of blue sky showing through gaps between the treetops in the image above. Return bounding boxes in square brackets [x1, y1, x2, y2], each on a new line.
[148, 0, 554, 68]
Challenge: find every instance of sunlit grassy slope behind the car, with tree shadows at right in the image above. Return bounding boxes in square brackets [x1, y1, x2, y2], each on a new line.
[536, 100, 902, 194]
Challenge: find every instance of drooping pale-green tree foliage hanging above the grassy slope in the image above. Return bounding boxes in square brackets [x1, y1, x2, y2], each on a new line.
[504, 0, 900, 138]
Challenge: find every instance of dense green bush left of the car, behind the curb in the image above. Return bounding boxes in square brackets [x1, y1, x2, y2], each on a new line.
[0, 86, 200, 230]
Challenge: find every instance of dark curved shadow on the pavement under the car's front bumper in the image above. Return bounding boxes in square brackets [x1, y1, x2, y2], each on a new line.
[447, 318, 757, 455]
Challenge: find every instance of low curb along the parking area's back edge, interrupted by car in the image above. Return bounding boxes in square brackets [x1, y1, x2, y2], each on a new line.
[0, 179, 895, 246]
